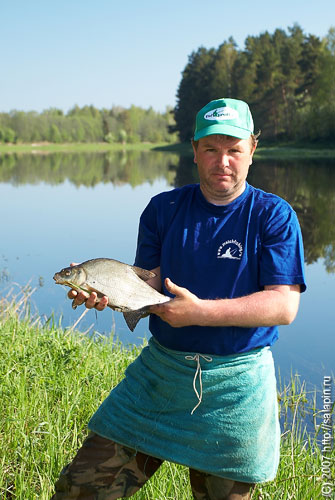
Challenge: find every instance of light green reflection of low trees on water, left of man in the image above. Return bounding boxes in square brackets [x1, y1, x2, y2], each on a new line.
[0, 151, 178, 187]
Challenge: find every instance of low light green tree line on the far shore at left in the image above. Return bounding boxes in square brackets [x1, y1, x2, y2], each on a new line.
[0, 106, 176, 144]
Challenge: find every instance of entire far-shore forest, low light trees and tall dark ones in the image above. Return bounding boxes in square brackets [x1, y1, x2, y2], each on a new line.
[0, 25, 335, 144]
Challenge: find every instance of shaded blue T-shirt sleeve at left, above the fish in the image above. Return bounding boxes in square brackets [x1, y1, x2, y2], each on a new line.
[135, 200, 161, 269]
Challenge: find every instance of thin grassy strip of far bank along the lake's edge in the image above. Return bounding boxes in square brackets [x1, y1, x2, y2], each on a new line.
[0, 142, 335, 160]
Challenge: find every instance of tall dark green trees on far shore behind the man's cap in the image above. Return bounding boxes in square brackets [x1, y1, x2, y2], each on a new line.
[173, 24, 335, 142]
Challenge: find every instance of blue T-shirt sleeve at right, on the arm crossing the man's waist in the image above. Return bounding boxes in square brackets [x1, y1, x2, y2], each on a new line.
[260, 207, 306, 292]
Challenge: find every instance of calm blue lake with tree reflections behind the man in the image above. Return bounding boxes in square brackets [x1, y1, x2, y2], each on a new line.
[0, 148, 335, 387]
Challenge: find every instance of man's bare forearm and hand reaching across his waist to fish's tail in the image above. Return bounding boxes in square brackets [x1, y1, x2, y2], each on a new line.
[150, 279, 300, 328]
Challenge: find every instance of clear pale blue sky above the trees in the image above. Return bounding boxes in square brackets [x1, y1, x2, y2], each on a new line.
[0, 0, 335, 112]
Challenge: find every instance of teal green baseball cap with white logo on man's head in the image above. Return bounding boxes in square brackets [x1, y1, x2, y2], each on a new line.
[194, 98, 254, 141]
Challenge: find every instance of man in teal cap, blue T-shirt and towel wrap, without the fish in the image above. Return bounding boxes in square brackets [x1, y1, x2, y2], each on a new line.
[52, 98, 306, 500]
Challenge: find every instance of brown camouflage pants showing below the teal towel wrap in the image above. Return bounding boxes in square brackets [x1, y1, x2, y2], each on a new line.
[51, 432, 253, 500]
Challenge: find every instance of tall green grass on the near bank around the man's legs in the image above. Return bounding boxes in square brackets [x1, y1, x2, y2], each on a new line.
[0, 290, 335, 500]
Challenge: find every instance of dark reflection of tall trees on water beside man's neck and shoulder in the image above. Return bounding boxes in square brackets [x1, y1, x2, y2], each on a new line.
[174, 156, 335, 273]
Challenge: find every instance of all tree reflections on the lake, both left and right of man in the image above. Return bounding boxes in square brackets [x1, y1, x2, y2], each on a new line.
[0, 151, 335, 272]
